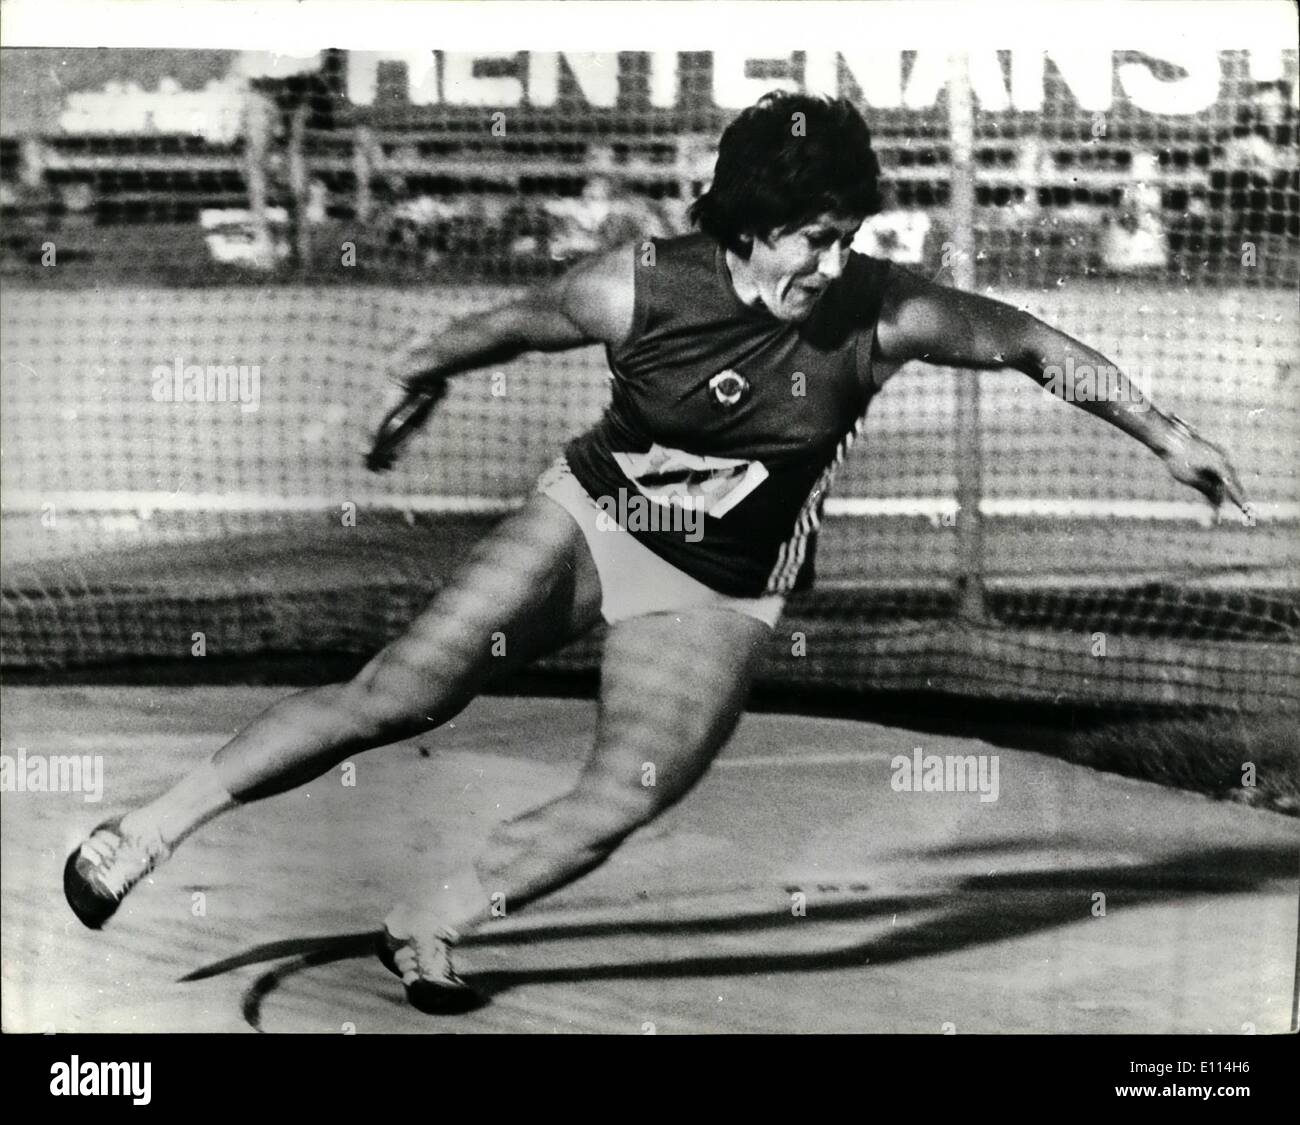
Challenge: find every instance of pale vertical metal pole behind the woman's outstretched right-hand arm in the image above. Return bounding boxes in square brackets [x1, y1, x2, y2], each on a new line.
[948, 51, 988, 622]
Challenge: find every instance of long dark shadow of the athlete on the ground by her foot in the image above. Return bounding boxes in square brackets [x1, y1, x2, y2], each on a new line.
[195, 840, 1300, 1027]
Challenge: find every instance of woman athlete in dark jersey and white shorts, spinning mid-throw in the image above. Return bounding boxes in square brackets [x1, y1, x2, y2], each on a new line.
[64, 94, 1244, 1012]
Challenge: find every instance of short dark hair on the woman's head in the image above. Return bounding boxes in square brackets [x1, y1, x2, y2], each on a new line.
[690, 90, 884, 258]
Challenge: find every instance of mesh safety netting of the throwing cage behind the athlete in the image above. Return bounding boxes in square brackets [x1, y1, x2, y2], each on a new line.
[0, 51, 1300, 708]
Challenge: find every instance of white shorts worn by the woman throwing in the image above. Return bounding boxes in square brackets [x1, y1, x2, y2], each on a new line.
[537, 457, 785, 628]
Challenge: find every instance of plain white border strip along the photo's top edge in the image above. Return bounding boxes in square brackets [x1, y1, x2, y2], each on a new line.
[0, 0, 1296, 56]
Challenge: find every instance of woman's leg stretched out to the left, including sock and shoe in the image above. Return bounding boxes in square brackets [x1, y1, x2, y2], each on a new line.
[65, 497, 601, 925]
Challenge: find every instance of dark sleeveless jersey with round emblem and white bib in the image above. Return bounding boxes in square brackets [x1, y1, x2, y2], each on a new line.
[564, 234, 889, 597]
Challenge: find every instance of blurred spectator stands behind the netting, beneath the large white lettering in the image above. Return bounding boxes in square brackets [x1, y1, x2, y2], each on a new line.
[0, 51, 1300, 284]
